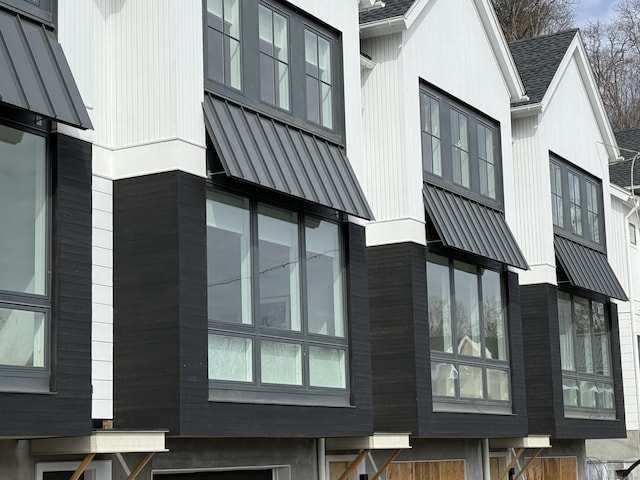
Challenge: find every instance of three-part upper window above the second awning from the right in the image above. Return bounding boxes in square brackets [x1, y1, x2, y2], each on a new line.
[420, 87, 502, 206]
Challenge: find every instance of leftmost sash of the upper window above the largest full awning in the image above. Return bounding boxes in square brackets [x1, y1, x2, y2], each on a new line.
[207, 0, 242, 90]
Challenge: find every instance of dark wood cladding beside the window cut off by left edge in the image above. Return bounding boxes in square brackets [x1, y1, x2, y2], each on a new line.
[0, 134, 91, 437]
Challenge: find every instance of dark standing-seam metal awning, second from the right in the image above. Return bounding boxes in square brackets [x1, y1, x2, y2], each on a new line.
[423, 183, 529, 270]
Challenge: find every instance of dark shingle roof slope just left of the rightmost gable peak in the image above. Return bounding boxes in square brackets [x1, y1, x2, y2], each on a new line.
[509, 28, 578, 105]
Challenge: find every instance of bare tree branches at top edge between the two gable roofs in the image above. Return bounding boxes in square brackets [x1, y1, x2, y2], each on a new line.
[491, 0, 577, 42]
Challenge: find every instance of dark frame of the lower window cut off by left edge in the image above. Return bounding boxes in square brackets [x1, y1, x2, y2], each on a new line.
[0, 108, 54, 393]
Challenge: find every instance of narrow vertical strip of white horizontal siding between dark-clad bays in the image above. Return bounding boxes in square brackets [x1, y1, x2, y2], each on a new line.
[91, 175, 113, 419]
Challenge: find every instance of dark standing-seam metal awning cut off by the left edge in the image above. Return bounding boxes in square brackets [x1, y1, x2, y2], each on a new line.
[0, 9, 93, 129]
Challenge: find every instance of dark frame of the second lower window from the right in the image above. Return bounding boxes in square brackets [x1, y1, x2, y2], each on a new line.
[425, 251, 513, 415]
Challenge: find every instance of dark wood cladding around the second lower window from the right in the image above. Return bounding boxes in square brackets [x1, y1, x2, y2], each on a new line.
[367, 243, 527, 438]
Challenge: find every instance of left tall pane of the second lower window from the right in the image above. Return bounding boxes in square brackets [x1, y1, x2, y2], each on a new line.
[427, 255, 453, 353]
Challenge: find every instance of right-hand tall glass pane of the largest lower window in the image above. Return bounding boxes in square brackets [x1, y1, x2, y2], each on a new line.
[305, 217, 345, 337]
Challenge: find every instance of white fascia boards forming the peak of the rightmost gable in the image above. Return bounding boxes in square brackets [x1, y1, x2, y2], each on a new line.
[541, 31, 620, 162]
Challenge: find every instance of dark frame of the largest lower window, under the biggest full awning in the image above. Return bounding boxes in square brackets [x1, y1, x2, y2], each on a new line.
[207, 183, 353, 407]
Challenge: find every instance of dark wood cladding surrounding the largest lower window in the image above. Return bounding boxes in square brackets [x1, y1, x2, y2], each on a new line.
[114, 172, 373, 437]
